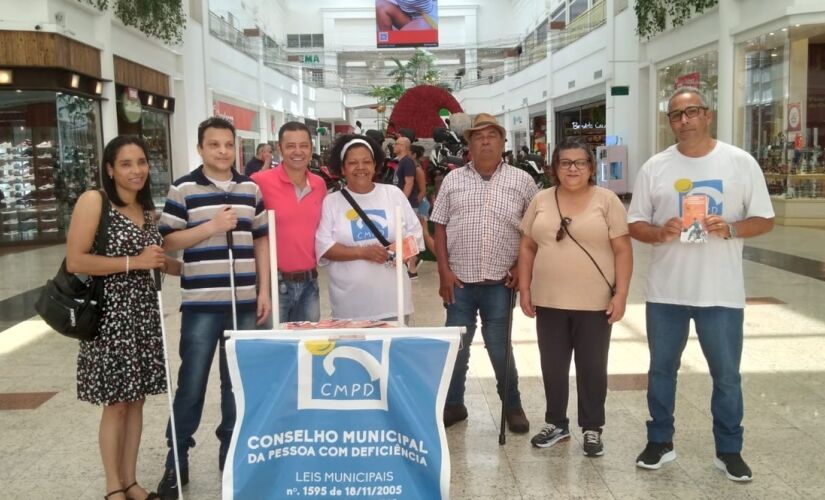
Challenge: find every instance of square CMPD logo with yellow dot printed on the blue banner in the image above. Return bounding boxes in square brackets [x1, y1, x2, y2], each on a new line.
[298, 340, 390, 411]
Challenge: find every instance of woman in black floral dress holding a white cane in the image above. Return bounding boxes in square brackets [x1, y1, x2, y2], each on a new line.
[66, 136, 180, 500]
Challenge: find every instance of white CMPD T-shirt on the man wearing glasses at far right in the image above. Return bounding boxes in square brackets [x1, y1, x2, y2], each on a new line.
[627, 141, 774, 308]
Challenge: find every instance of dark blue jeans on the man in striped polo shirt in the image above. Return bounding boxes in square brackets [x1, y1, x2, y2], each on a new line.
[166, 309, 255, 469]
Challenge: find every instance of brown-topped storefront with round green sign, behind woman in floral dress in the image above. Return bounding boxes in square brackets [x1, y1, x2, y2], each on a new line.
[114, 56, 175, 207]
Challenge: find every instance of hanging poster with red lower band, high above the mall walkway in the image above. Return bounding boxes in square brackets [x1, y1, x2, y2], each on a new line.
[375, 0, 438, 49]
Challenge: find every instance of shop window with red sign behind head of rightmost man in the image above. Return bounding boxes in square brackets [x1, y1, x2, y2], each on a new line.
[656, 50, 719, 151]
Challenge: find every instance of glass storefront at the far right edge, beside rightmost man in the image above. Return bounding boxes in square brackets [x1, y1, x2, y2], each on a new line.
[734, 24, 825, 227]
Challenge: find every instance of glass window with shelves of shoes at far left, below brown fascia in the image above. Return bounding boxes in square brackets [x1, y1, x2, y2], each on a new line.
[0, 91, 100, 243]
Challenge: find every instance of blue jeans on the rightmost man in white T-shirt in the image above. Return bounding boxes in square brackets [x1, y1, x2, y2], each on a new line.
[646, 302, 744, 453]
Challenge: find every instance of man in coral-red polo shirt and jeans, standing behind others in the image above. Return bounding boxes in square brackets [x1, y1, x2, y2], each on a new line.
[252, 122, 327, 326]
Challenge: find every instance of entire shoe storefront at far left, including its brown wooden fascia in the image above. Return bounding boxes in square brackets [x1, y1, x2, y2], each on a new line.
[0, 31, 104, 246]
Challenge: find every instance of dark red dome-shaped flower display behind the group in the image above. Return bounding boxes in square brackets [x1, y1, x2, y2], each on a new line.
[387, 85, 463, 138]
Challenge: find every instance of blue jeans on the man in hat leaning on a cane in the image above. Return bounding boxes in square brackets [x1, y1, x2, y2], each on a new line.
[446, 283, 521, 408]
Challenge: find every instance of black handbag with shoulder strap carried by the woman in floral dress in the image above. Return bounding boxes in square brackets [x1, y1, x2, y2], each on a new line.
[34, 191, 111, 340]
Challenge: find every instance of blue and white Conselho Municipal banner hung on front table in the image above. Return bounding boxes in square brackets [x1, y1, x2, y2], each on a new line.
[223, 328, 459, 500]
